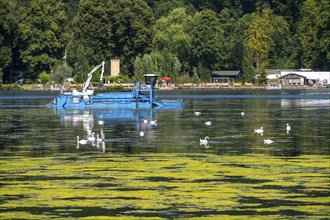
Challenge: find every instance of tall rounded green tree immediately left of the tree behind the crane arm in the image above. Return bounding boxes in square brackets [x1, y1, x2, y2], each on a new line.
[19, 0, 67, 78]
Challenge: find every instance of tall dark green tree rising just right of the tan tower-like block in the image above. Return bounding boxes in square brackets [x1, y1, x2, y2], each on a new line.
[111, 0, 154, 75]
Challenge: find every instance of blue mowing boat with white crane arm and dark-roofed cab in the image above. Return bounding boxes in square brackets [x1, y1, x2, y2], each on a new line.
[47, 62, 184, 109]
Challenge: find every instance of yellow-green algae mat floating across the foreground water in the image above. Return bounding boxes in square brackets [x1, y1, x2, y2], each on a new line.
[0, 154, 330, 219]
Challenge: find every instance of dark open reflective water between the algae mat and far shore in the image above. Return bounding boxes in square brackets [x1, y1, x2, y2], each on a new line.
[0, 90, 330, 156]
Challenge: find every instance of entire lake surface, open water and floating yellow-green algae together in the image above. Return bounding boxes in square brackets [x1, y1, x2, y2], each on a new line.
[0, 89, 330, 219]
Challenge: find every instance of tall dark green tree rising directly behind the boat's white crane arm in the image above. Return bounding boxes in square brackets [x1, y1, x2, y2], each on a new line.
[68, 0, 114, 67]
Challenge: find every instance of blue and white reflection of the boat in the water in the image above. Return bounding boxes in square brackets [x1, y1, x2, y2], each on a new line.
[54, 108, 181, 153]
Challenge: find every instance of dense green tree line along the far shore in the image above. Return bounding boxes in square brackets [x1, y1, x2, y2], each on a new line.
[0, 0, 330, 83]
